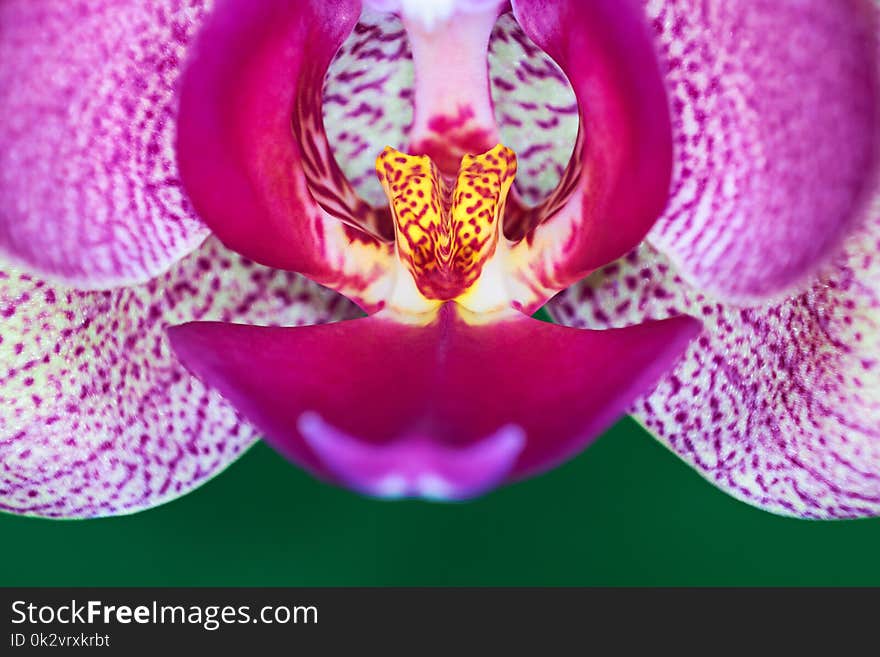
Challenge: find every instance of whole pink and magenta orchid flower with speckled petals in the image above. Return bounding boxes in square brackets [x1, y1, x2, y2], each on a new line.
[0, 0, 880, 517]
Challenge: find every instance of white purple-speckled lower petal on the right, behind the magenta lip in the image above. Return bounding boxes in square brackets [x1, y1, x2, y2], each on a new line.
[550, 203, 880, 518]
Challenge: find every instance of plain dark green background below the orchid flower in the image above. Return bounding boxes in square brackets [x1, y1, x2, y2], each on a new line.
[0, 419, 880, 585]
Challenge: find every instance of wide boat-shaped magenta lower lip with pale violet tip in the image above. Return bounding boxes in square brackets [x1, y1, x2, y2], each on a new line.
[170, 305, 699, 499]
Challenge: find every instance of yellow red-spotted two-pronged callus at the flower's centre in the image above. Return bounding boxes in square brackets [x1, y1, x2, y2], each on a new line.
[376, 144, 516, 316]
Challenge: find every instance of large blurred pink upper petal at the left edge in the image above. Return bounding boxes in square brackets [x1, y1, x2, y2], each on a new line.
[0, 0, 210, 289]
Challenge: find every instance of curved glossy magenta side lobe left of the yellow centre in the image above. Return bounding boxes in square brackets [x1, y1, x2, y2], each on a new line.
[177, 0, 393, 310]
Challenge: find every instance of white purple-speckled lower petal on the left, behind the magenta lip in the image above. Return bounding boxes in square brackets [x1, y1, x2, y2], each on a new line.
[0, 239, 354, 518]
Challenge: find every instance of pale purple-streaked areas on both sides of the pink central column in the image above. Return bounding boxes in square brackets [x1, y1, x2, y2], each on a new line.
[323, 9, 578, 206]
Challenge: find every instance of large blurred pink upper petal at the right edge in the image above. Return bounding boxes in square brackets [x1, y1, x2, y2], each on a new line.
[647, 0, 880, 301]
